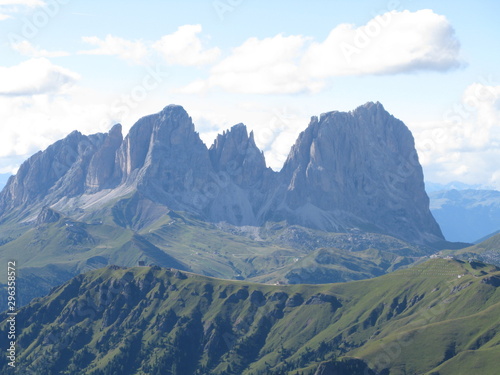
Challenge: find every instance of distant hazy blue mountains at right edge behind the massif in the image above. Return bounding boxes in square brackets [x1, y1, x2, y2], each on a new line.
[429, 189, 500, 243]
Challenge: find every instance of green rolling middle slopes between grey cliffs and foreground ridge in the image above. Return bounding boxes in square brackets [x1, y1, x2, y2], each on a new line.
[0, 204, 430, 305]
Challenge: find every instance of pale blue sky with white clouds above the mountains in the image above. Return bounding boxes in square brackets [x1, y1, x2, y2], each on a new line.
[0, 0, 500, 189]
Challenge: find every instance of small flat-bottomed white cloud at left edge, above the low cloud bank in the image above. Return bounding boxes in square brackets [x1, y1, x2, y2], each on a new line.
[0, 57, 80, 96]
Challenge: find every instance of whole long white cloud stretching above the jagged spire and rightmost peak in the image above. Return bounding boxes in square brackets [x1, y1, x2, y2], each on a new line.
[181, 10, 462, 94]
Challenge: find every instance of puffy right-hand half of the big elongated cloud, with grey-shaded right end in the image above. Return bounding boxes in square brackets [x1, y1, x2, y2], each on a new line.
[303, 9, 461, 77]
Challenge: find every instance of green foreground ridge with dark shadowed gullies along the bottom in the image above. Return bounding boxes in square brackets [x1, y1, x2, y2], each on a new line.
[0, 259, 500, 375]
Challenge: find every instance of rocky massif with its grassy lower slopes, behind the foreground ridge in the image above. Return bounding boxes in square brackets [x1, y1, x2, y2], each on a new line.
[0, 103, 451, 303]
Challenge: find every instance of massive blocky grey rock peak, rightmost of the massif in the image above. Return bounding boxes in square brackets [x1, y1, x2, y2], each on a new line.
[274, 103, 442, 242]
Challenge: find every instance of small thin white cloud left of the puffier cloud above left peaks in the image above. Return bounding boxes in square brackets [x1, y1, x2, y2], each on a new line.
[78, 35, 148, 64]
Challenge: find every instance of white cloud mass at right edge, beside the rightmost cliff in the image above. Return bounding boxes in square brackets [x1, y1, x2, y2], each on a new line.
[412, 82, 500, 189]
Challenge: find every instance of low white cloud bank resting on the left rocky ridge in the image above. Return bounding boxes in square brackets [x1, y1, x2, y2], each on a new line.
[0, 87, 117, 166]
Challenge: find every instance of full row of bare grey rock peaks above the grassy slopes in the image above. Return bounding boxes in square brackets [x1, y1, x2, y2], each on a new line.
[0, 103, 442, 243]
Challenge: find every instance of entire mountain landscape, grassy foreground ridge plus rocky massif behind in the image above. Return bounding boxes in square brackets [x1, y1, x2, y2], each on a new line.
[0, 103, 500, 375]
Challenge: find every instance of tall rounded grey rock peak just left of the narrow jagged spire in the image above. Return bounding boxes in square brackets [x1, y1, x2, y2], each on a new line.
[115, 105, 212, 210]
